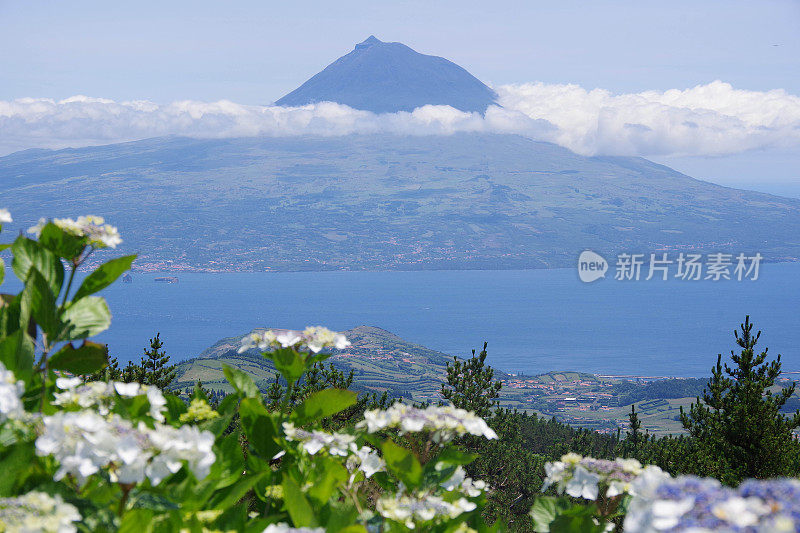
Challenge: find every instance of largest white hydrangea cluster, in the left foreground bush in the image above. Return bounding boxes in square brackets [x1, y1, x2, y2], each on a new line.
[36, 410, 215, 485]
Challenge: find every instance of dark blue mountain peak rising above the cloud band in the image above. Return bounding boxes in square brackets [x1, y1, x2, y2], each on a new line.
[276, 35, 497, 113]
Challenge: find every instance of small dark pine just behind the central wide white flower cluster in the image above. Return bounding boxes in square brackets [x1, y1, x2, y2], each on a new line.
[442, 343, 503, 418]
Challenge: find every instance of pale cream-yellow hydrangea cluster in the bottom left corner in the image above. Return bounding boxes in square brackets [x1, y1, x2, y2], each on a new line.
[0, 491, 81, 533]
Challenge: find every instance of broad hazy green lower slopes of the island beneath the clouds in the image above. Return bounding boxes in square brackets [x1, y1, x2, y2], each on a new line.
[0, 133, 800, 273]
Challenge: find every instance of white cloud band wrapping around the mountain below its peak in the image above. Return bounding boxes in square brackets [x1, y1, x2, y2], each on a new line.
[0, 81, 800, 156]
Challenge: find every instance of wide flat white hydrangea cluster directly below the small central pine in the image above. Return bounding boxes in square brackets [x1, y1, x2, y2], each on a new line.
[359, 402, 497, 443]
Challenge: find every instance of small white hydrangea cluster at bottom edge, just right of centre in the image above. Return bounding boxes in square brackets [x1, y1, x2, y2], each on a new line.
[376, 493, 477, 529]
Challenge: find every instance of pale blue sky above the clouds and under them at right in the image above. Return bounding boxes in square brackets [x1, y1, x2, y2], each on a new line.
[0, 0, 800, 194]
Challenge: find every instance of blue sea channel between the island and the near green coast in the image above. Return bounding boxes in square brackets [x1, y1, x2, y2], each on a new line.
[4, 263, 800, 376]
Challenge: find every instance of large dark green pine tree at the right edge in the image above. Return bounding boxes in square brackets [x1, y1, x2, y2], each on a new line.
[681, 316, 800, 484]
